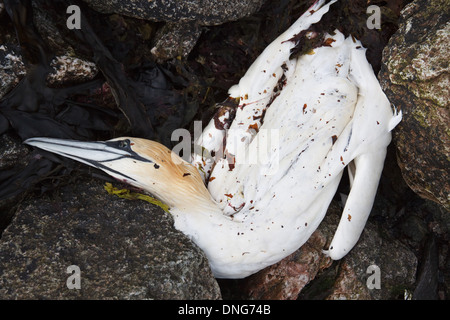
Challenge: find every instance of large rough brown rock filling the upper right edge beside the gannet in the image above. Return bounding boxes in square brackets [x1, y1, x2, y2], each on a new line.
[379, 0, 450, 210]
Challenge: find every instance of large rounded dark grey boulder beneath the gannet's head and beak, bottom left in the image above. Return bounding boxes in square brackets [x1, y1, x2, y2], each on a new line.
[0, 181, 221, 299]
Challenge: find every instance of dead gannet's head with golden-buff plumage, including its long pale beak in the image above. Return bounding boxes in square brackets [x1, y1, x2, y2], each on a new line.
[24, 137, 210, 208]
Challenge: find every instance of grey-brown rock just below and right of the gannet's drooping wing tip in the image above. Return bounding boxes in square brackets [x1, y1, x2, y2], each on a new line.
[327, 222, 417, 300]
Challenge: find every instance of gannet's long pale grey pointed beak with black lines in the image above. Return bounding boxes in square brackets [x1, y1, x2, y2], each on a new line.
[24, 138, 152, 182]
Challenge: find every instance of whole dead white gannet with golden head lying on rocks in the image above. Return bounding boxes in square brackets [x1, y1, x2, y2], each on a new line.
[25, 1, 401, 278]
